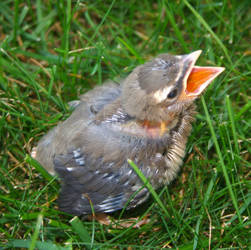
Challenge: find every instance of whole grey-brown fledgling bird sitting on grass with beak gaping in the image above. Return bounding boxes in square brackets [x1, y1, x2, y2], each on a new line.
[32, 50, 224, 215]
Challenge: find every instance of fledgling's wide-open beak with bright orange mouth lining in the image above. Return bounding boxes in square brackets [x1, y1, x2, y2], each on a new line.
[179, 50, 225, 101]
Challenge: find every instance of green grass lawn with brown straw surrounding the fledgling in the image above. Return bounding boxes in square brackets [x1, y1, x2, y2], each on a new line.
[0, 0, 251, 249]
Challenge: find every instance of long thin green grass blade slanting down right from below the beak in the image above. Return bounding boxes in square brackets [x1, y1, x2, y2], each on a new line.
[201, 96, 242, 223]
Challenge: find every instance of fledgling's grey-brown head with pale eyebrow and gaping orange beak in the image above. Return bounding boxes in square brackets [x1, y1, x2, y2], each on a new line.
[122, 50, 224, 122]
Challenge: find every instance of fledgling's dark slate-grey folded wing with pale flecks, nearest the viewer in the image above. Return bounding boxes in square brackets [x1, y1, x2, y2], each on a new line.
[54, 149, 129, 215]
